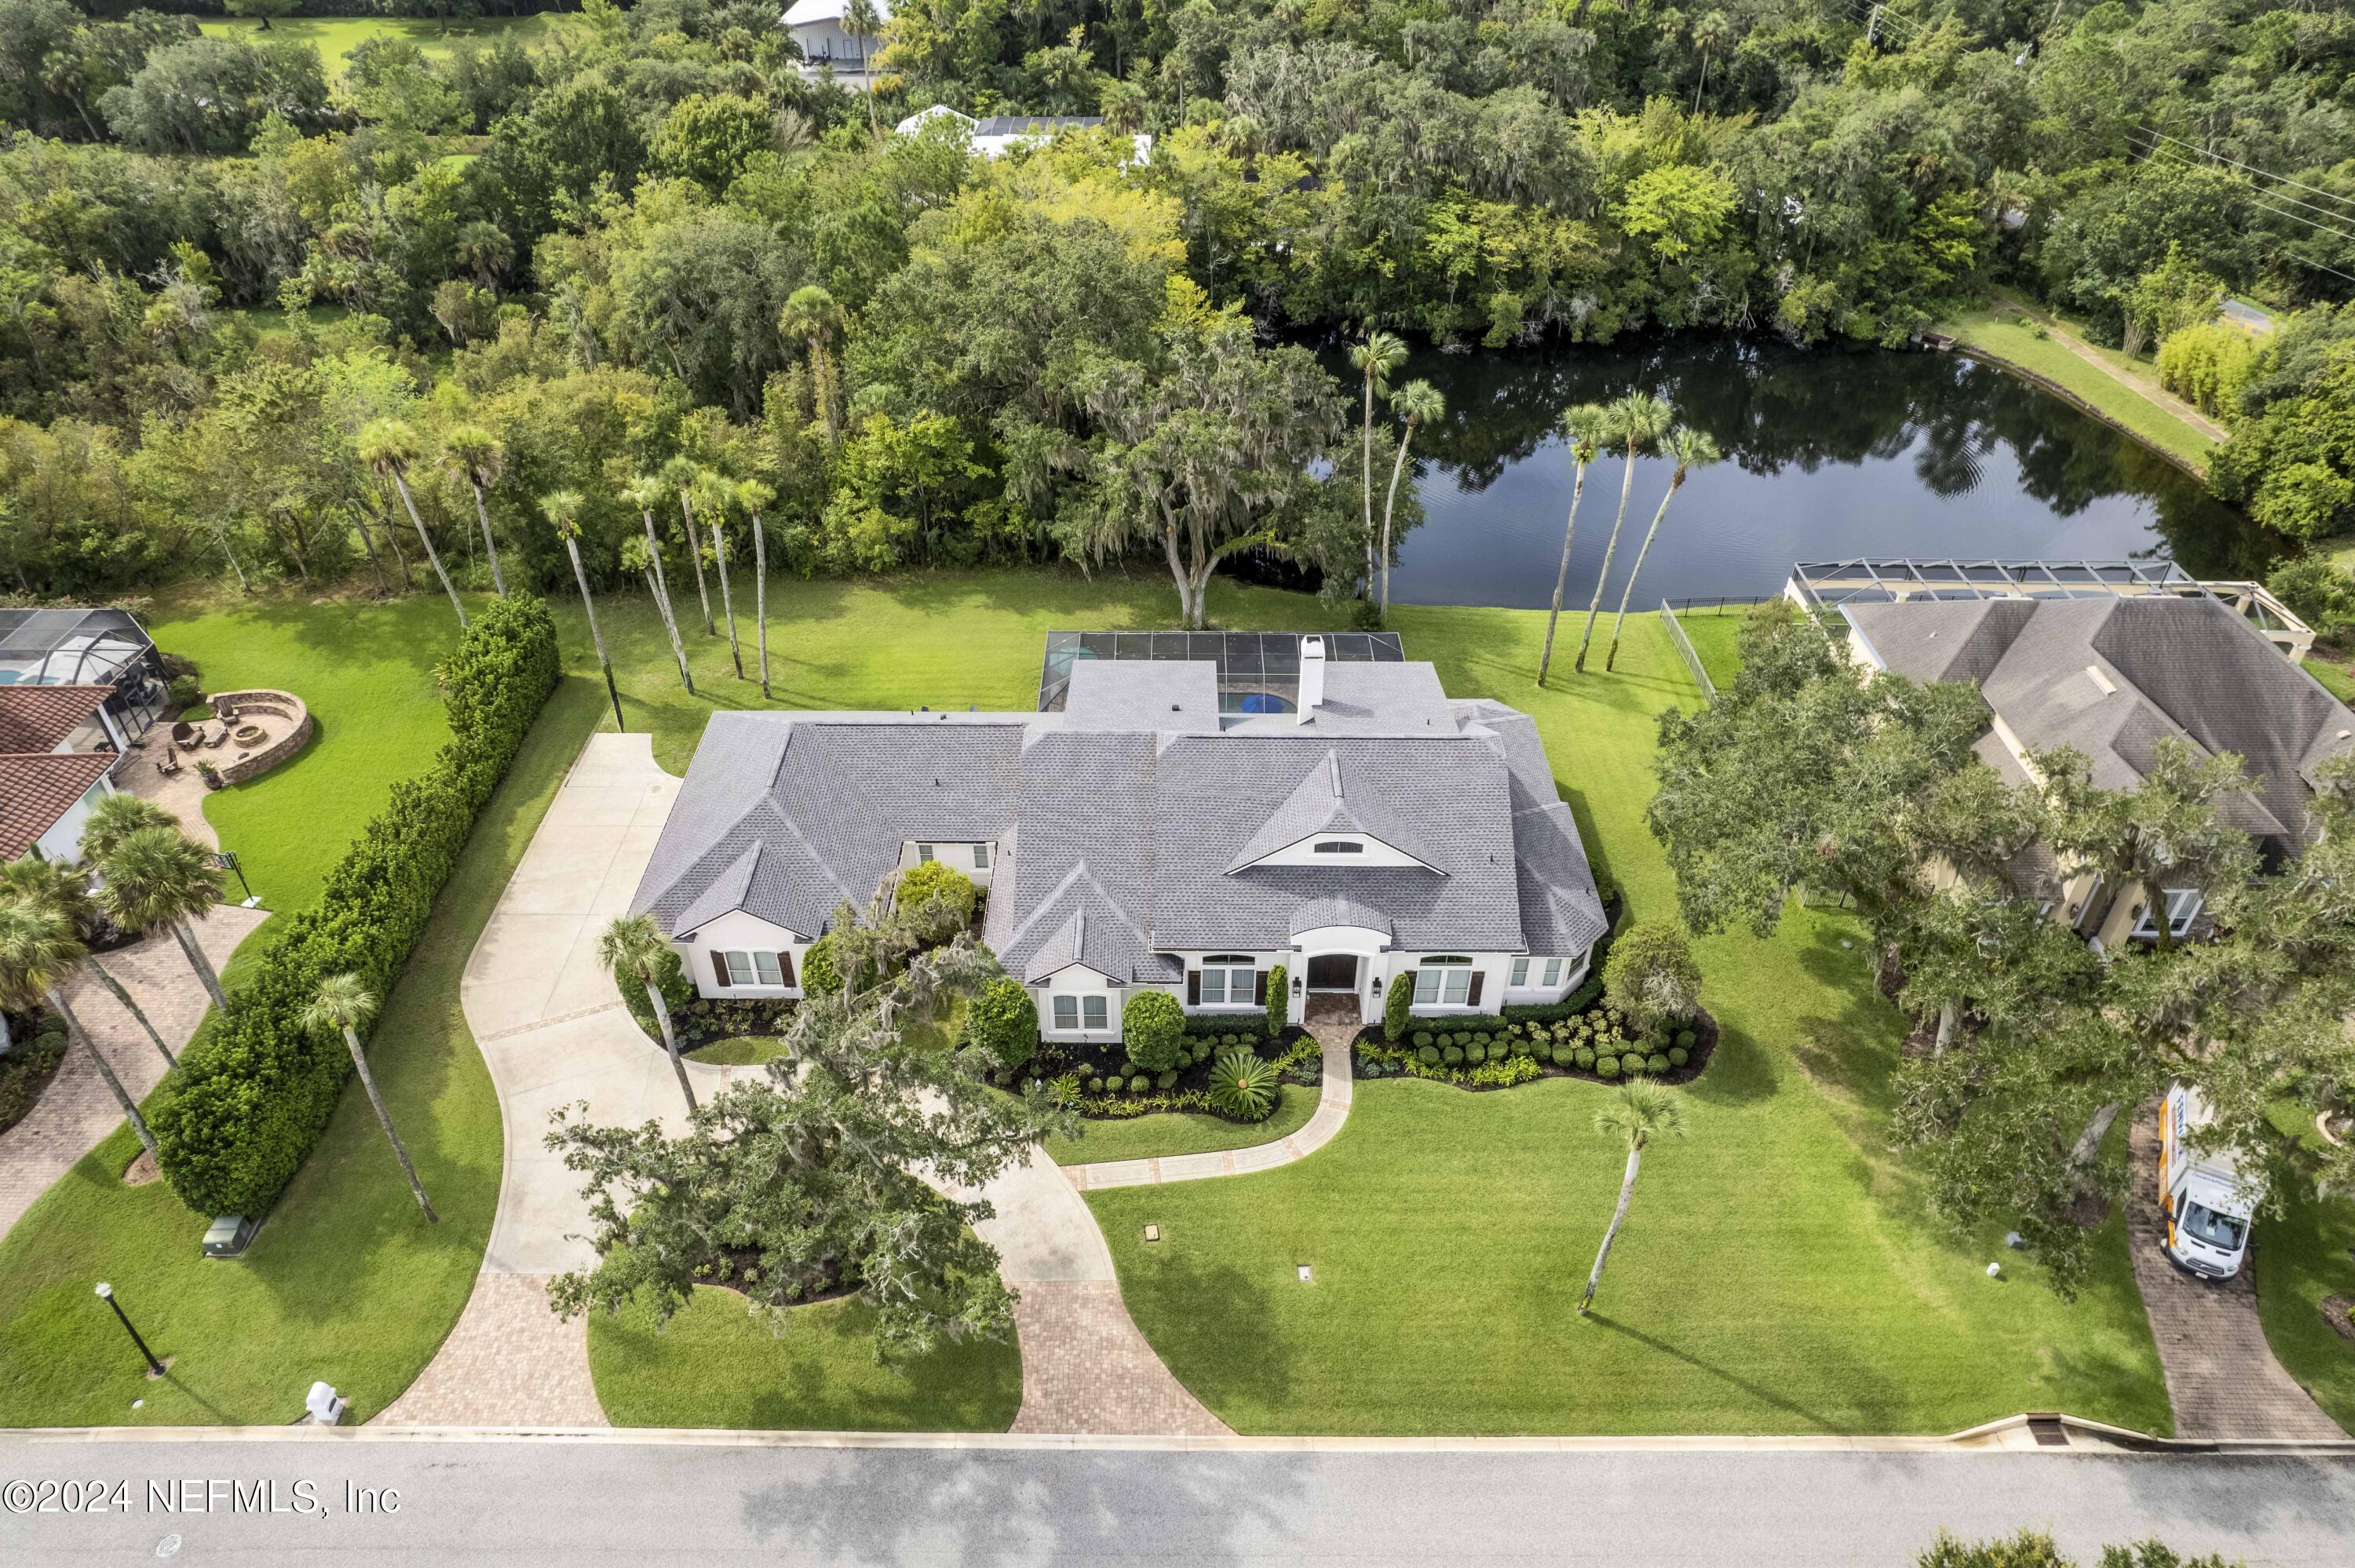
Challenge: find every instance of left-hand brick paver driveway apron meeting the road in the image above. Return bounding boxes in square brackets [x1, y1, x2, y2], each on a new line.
[372, 1274, 612, 1427]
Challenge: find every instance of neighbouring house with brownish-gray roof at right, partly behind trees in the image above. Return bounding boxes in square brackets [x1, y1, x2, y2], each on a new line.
[1842, 593, 2355, 946]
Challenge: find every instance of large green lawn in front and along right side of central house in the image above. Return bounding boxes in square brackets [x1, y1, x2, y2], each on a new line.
[1088, 607, 2171, 1431]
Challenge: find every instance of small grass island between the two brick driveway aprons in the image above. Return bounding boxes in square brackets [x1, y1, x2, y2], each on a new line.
[589, 1285, 1022, 1431]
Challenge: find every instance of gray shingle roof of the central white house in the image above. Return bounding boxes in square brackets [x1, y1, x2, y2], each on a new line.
[631, 645, 1604, 965]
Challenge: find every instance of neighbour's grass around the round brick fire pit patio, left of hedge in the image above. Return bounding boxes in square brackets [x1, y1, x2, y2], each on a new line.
[148, 593, 457, 911]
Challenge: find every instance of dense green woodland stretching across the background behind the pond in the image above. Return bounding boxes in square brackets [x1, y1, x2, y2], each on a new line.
[0, 0, 2355, 610]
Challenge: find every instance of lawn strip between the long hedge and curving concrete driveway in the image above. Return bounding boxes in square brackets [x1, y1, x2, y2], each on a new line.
[0, 664, 603, 1427]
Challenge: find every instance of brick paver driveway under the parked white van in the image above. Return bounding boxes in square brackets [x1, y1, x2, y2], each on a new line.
[2127, 1107, 2346, 1439]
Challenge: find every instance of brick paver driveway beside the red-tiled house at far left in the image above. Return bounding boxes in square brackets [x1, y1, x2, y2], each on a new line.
[0, 904, 268, 1236]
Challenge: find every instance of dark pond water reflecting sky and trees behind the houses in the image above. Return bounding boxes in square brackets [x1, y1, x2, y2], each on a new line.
[1356, 337, 2266, 607]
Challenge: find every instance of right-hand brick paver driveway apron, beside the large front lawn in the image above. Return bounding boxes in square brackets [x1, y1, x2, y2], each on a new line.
[1013, 1278, 1232, 1436]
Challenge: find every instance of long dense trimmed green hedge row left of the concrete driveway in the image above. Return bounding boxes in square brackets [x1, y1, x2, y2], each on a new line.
[148, 598, 558, 1215]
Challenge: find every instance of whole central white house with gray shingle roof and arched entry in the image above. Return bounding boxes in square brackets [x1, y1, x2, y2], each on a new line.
[631, 638, 1606, 1041]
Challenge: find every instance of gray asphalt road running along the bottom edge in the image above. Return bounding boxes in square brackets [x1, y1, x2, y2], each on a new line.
[0, 1434, 2355, 1568]
